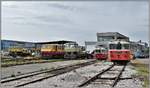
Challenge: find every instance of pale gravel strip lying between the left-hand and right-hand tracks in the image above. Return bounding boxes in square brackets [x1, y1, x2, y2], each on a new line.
[16, 63, 108, 88]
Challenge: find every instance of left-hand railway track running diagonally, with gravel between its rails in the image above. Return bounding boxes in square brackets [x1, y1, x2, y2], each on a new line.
[1, 60, 96, 87]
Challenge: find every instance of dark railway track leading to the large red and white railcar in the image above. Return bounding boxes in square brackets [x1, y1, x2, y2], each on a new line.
[78, 64, 131, 88]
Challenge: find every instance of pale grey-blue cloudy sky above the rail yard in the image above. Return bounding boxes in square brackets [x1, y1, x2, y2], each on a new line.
[1, 1, 149, 45]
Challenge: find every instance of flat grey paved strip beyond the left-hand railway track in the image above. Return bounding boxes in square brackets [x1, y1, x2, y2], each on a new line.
[1, 59, 94, 78]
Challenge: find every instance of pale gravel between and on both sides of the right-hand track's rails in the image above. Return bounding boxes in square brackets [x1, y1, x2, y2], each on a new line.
[2, 62, 142, 88]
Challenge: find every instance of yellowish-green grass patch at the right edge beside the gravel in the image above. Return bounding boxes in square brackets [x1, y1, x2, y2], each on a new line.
[133, 63, 149, 88]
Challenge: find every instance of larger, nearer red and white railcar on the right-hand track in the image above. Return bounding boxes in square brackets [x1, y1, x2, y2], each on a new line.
[108, 41, 131, 62]
